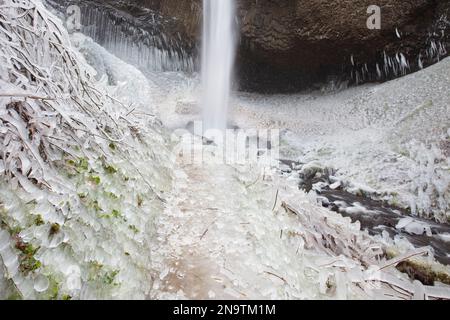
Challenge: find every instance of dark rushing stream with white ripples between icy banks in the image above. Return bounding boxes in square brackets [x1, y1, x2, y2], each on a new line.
[281, 161, 450, 265]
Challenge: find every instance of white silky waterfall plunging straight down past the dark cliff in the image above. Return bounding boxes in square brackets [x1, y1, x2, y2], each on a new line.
[202, 0, 236, 130]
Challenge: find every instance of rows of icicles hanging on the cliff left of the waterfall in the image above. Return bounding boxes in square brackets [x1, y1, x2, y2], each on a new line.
[49, 1, 195, 72]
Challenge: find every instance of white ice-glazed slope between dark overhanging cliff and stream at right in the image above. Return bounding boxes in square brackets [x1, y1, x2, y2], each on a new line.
[233, 59, 450, 221]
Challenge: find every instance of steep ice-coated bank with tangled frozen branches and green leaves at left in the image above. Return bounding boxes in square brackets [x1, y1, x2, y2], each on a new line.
[0, 0, 172, 299]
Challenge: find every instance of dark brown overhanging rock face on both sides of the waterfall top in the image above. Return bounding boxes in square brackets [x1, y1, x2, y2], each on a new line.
[47, 0, 450, 92]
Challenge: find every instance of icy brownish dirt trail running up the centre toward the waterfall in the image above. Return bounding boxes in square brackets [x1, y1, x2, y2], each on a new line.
[151, 162, 243, 299]
